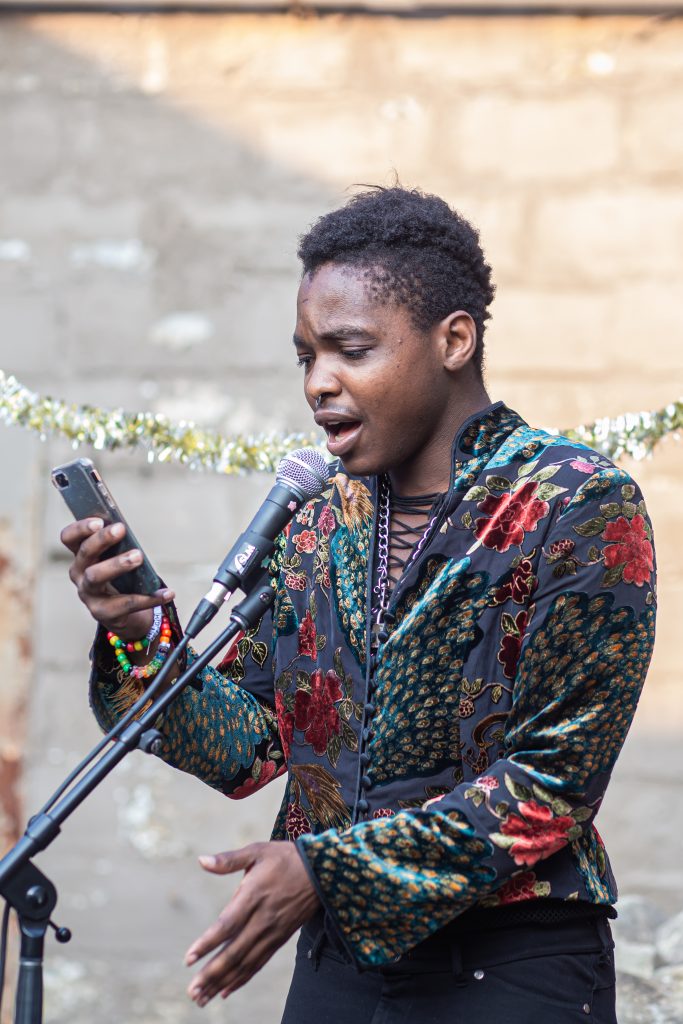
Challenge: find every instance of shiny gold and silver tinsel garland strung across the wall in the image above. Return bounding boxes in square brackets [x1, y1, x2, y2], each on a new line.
[0, 370, 683, 473]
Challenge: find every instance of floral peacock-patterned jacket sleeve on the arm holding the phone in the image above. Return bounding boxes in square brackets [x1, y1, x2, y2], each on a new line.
[90, 552, 286, 800]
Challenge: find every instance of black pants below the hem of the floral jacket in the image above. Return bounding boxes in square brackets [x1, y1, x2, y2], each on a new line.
[282, 915, 616, 1024]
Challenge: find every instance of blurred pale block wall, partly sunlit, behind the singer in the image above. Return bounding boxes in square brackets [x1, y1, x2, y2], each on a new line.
[0, 0, 683, 1024]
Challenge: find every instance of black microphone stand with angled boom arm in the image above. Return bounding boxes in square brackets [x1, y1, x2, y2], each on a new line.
[0, 577, 274, 1024]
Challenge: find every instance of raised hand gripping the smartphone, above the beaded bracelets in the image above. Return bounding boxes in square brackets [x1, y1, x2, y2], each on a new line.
[59, 518, 175, 640]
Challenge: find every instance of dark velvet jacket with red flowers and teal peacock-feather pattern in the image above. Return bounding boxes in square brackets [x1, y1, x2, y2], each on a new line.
[91, 403, 655, 967]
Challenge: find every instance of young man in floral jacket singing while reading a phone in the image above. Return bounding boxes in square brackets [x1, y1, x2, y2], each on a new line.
[62, 187, 655, 1024]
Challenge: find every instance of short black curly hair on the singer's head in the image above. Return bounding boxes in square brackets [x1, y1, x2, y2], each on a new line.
[298, 185, 495, 375]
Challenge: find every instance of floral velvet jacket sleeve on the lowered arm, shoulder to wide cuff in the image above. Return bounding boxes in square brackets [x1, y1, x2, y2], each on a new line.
[297, 469, 654, 966]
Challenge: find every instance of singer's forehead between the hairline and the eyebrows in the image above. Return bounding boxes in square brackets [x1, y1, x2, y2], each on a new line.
[297, 263, 408, 333]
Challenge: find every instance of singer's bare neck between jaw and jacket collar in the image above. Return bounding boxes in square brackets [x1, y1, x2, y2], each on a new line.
[389, 383, 490, 497]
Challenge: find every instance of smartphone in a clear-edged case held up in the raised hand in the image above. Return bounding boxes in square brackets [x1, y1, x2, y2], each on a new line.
[50, 459, 164, 594]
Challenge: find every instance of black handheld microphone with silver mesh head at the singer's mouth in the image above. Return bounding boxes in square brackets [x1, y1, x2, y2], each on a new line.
[185, 449, 329, 638]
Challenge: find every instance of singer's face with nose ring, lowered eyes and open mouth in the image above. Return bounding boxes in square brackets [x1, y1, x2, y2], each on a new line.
[294, 263, 471, 484]
